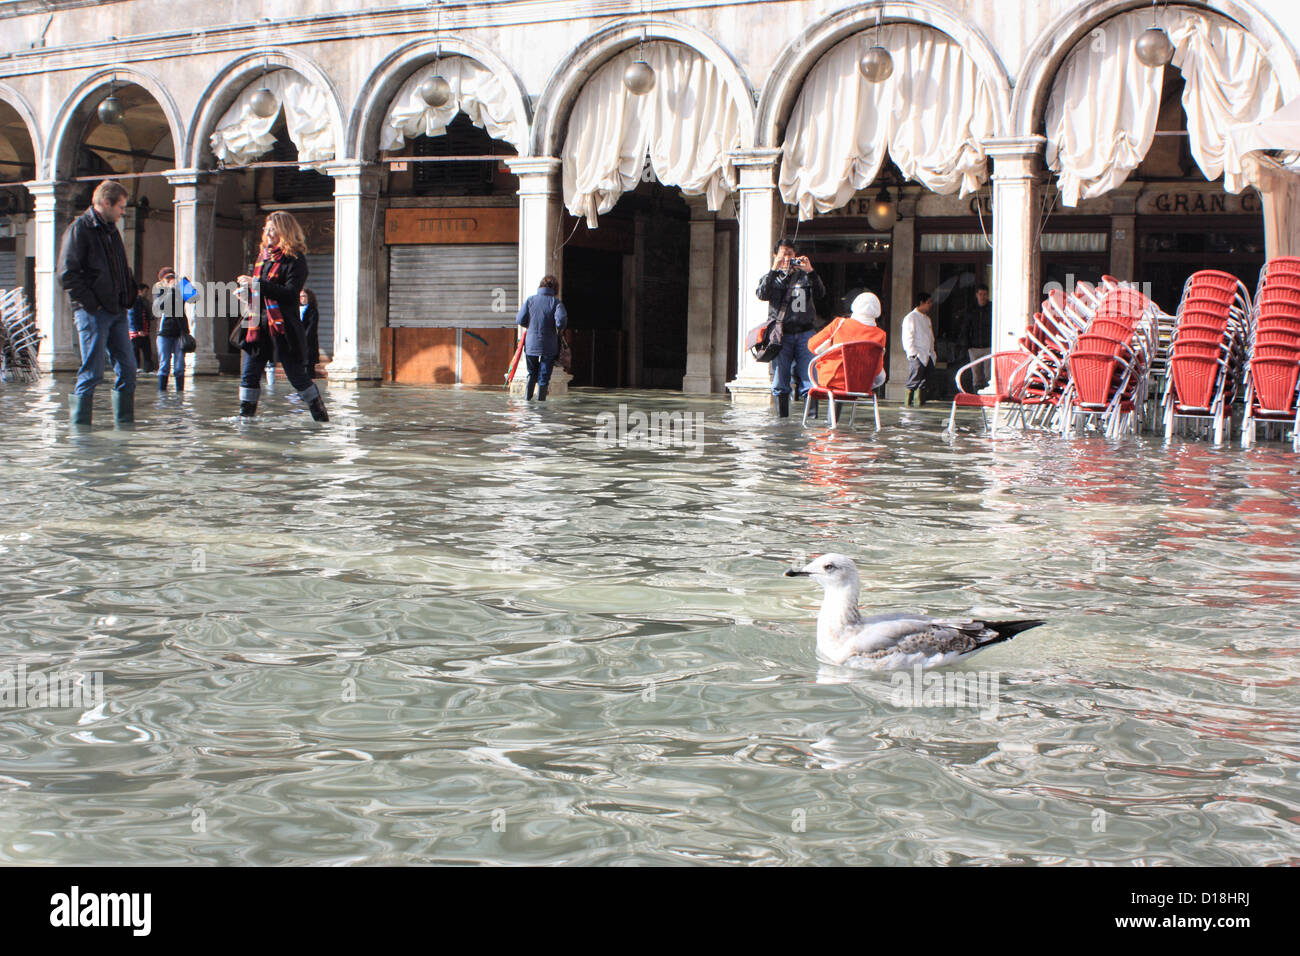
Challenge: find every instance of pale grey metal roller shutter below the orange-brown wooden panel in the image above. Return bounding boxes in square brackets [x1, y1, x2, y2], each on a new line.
[389, 243, 519, 329]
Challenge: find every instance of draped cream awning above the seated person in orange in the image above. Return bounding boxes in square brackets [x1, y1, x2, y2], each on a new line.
[780, 23, 997, 219]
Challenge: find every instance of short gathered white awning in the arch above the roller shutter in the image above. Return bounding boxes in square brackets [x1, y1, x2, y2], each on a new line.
[380, 56, 528, 152]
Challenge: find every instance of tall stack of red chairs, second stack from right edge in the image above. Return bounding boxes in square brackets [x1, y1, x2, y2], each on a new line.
[1161, 269, 1251, 445]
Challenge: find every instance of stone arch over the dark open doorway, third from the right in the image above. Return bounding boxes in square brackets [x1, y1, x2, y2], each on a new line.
[530, 17, 755, 156]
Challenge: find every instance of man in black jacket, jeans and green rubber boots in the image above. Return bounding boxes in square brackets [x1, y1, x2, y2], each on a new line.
[59, 179, 135, 425]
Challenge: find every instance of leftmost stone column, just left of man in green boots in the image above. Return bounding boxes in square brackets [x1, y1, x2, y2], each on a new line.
[27, 181, 81, 372]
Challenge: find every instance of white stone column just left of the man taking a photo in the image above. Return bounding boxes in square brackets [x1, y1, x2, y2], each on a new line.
[727, 150, 781, 403]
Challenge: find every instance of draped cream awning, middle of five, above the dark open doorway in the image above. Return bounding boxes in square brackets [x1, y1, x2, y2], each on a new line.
[560, 42, 741, 226]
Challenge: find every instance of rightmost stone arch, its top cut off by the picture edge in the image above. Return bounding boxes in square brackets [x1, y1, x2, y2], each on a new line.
[1011, 0, 1300, 137]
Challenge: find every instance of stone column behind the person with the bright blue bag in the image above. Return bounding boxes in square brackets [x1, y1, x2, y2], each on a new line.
[165, 169, 220, 375]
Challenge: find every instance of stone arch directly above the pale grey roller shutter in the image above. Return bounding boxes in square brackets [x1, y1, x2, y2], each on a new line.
[347, 36, 532, 161]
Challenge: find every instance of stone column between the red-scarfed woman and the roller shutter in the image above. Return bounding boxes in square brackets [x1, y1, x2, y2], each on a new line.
[325, 163, 384, 386]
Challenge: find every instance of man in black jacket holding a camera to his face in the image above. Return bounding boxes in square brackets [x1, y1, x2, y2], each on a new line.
[758, 239, 826, 418]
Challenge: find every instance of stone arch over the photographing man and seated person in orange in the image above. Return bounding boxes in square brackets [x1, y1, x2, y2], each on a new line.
[758, 0, 1011, 148]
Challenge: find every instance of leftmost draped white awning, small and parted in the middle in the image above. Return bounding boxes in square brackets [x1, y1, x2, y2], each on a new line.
[211, 70, 335, 165]
